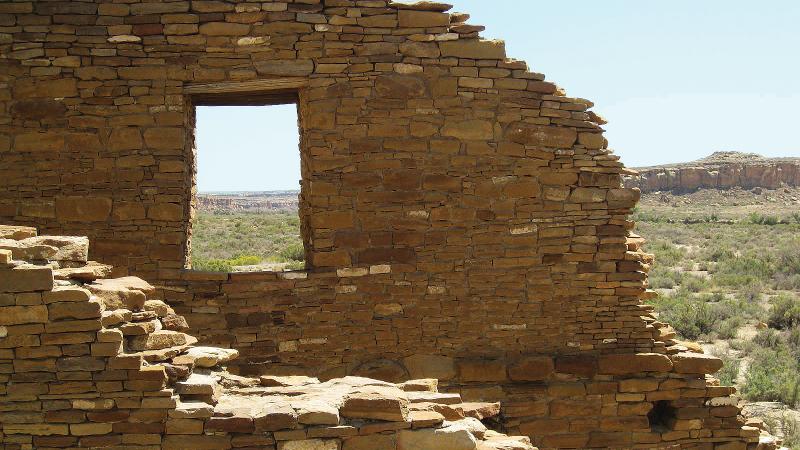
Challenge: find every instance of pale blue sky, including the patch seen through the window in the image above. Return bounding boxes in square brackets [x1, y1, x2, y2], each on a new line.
[198, 0, 800, 191]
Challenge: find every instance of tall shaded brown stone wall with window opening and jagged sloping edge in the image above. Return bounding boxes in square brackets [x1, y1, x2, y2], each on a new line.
[0, 0, 768, 448]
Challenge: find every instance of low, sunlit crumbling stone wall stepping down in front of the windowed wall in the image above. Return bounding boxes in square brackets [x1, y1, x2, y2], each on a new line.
[0, 227, 534, 450]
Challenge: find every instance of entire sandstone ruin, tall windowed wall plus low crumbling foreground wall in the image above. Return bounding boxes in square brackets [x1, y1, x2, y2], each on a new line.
[0, 0, 774, 450]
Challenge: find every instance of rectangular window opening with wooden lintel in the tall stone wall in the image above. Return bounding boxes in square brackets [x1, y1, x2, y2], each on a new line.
[189, 94, 306, 272]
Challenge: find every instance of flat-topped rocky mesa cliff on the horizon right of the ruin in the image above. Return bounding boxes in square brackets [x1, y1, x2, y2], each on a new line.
[624, 152, 800, 193]
